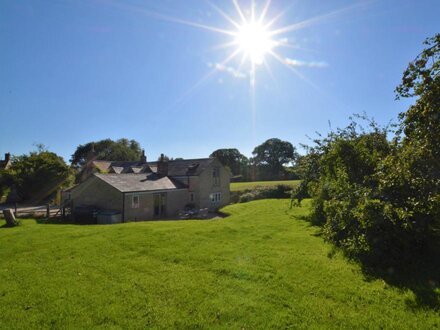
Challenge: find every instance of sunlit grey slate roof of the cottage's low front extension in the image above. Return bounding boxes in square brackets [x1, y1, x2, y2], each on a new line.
[94, 173, 186, 192]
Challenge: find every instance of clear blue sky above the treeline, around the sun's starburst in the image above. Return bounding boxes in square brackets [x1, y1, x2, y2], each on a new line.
[0, 0, 440, 160]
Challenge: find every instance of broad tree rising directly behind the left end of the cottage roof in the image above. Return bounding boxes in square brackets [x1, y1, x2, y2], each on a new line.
[70, 139, 142, 167]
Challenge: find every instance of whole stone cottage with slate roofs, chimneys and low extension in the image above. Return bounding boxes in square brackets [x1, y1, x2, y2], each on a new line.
[64, 153, 230, 221]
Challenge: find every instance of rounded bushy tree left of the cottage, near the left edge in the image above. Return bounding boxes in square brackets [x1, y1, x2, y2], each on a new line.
[7, 149, 72, 202]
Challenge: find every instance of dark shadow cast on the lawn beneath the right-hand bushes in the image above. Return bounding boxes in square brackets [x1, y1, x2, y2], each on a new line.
[361, 243, 440, 311]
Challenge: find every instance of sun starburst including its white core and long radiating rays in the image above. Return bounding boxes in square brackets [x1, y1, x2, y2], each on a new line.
[109, 0, 358, 88]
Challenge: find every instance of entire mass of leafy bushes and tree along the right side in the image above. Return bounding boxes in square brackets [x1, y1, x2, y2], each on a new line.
[292, 35, 440, 264]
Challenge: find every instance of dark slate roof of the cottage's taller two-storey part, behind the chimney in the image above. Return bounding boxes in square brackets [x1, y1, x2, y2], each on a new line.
[148, 158, 214, 176]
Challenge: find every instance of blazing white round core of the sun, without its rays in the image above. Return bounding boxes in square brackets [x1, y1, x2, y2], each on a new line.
[235, 21, 275, 65]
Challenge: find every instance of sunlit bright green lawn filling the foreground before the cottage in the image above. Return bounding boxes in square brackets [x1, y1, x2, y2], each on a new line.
[0, 200, 440, 329]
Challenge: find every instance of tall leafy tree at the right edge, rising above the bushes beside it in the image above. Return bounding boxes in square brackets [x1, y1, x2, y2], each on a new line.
[379, 34, 440, 240]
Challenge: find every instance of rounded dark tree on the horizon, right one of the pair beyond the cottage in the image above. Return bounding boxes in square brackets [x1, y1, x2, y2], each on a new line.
[252, 138, 298, 178]
